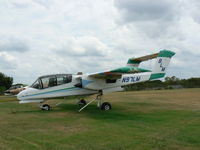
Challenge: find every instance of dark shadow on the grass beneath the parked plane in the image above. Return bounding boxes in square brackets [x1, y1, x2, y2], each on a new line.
[11, 104, 152, 122]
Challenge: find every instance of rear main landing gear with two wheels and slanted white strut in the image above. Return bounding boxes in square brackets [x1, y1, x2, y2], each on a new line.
[78, 91, 112, 112]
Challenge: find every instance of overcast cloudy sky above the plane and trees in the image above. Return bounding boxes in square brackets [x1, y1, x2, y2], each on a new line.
[0, 0, 200, 84]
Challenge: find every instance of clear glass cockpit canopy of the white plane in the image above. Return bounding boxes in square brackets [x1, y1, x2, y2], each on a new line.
[31, 74, 72, 89]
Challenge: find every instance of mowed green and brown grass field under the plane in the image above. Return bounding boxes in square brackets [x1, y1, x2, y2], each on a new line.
[0, 89, 200, 150]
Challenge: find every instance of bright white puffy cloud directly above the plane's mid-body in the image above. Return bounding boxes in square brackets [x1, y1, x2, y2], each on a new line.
[51, 36, 109, 58]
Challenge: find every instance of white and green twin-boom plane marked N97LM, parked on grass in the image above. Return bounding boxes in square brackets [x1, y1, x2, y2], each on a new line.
[17, 50, 175, 111]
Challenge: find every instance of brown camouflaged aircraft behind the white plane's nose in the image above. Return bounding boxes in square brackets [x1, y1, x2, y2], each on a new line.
[4, 84, 26, 96]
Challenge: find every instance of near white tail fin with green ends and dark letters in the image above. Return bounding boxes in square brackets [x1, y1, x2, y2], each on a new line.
[150, 50, 175, 80]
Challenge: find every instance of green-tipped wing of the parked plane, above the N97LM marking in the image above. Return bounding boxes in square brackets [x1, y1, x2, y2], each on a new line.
[88, 66, 150, 79]
